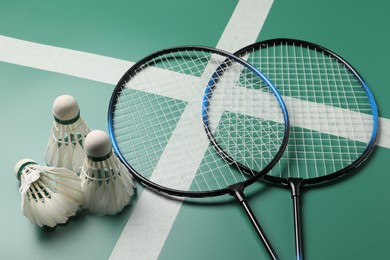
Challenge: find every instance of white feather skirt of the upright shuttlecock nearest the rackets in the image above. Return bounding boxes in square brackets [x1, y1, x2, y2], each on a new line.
[80, 153, 136, 215]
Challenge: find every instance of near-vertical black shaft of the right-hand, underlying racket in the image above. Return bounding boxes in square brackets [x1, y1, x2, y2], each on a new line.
[290, 179, 303, 260]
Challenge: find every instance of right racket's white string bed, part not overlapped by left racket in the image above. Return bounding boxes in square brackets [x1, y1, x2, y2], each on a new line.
[245, 43, 373, 178]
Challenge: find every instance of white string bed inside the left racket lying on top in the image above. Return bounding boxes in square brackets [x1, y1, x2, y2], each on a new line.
[113, 48, 285, 195]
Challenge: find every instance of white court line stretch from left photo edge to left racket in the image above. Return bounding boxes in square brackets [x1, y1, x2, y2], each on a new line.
[0, 35, 134, 85]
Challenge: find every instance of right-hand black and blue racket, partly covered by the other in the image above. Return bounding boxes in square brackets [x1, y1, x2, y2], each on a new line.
[235, 39, 378, 259]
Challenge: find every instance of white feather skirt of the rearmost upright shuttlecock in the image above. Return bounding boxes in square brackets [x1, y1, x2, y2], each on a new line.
[45, 117, 91, 174]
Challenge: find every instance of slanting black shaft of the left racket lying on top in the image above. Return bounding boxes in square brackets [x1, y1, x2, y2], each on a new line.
[230, 184, 279, 260]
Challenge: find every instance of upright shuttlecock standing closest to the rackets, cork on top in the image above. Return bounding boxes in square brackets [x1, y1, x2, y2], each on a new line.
[80, 130, 135, 215]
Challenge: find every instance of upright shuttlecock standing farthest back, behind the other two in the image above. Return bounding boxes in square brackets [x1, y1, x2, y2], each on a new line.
[45, 95, 91, 174]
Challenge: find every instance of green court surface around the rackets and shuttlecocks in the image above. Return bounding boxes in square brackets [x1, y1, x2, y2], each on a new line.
[0, 0, 390, 260]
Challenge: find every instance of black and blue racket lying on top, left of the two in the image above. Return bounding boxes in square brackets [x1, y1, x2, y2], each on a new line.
[108, 46, 289, 259]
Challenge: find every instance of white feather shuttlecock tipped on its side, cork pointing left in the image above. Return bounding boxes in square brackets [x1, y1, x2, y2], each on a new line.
[14, 159, 83, 227]
